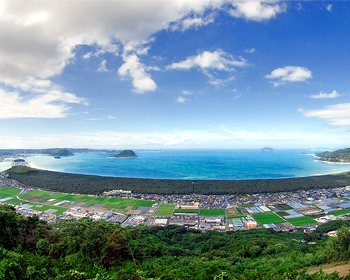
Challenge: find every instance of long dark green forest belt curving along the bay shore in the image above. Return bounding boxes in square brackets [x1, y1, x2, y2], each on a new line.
[5, 167, 350, 195]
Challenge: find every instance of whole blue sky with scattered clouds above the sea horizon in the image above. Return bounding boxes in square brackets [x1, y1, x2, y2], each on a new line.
[0, 0, 350, 149]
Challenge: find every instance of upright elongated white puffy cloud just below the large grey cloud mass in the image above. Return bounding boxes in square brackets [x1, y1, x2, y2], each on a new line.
[118, 54, 157, 93]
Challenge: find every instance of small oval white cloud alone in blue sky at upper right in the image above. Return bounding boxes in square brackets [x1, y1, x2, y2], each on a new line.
[265, 66, 312, 87]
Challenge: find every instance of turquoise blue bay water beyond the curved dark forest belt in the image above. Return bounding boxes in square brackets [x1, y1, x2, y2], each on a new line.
[15, 150, 350, 180]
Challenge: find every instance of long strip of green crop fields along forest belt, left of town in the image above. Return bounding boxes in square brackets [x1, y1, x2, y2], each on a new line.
[20, 190, 155, 212]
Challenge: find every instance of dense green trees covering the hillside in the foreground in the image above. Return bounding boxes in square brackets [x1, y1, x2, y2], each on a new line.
[0, 206, 350, 280]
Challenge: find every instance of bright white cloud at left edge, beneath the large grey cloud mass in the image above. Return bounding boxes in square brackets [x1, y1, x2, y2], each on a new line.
[0, 89, 88, 119]
